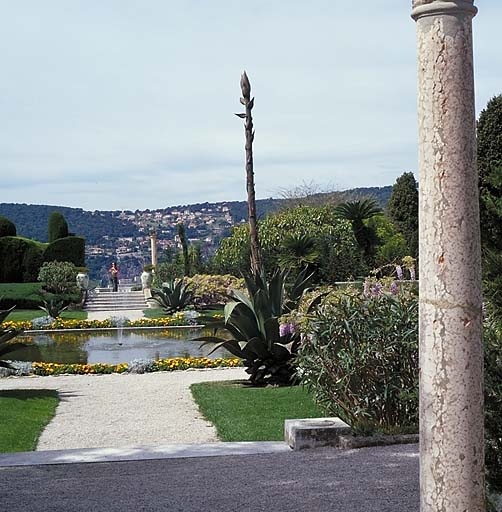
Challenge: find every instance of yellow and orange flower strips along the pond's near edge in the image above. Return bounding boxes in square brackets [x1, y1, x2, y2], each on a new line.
[33, 357, 242, 376]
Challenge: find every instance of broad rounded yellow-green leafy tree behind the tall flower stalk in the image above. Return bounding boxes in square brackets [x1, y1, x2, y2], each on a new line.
[213, 206, 364, 282]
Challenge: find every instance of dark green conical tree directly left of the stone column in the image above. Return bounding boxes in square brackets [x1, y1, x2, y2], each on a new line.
[387, 172, 418, 258]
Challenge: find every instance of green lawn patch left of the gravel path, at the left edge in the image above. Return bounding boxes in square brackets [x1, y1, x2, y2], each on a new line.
[0, 389, 59, 453]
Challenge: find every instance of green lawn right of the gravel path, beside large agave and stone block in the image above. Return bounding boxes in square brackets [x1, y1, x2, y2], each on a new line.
[190, 382, 325, 441]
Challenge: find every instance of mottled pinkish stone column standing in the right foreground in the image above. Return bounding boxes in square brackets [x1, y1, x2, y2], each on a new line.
[412, 0, 484, 512]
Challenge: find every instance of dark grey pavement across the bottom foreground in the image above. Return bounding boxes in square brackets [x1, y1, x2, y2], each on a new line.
[0, 445, 419, 512]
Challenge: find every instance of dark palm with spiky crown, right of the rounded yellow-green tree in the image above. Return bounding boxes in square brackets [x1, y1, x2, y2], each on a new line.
[335, 199, 382, 267]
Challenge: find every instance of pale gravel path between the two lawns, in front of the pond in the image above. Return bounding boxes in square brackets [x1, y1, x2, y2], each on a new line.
[0, 368, 247, 450]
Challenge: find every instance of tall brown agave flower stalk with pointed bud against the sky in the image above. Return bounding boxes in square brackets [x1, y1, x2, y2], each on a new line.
[236, 71, 262, 276]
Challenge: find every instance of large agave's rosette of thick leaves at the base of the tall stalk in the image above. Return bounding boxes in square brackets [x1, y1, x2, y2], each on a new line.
[197, 269, 312, 386]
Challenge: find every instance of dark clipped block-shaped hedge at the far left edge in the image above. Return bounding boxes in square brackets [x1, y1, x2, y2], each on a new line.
[0, 236, 45, 283]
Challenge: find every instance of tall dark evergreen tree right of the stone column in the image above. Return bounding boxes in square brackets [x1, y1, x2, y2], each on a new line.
[477, 95, 502, 253]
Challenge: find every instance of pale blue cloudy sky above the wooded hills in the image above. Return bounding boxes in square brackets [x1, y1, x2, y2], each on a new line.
[0, 0, 502, 210]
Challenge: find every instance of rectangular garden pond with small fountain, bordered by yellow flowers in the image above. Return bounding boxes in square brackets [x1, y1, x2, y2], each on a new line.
[9, 328, 233, 364]
